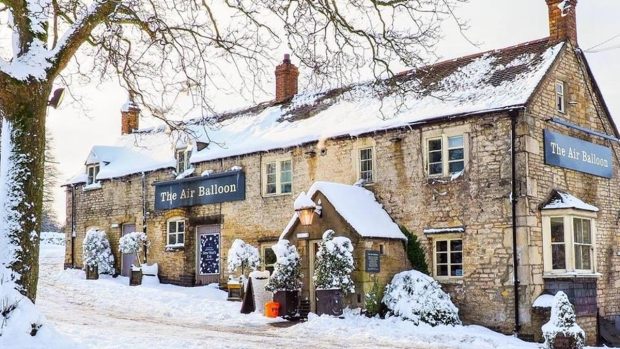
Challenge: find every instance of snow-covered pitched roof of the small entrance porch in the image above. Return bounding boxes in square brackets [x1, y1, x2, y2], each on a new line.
[280, 182, 407, 240]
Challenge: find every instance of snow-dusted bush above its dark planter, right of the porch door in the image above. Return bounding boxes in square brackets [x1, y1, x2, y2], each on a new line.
[314, 230, 355, 293]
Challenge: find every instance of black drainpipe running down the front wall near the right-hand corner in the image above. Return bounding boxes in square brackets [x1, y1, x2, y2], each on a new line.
[509, 110, 521, 335]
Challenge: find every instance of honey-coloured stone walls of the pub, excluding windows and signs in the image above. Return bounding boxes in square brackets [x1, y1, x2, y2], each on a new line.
[66, 44, 620, 343]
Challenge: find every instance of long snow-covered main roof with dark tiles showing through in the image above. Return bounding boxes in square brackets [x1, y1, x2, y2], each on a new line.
[66, 39, 565, 184]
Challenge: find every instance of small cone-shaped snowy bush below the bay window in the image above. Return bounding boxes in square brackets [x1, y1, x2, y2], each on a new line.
[542, 291, 585, 349]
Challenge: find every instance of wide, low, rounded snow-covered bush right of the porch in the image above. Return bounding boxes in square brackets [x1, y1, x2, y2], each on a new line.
[383, 270, 461, 326]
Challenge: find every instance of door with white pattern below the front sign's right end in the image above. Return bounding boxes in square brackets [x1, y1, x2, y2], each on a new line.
[196, 224, 221, 285]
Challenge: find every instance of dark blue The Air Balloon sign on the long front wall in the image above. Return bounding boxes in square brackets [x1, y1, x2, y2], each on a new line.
[155, 171, 245, 211]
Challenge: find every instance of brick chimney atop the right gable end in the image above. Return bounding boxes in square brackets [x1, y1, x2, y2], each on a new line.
[546, 0, 578, 47]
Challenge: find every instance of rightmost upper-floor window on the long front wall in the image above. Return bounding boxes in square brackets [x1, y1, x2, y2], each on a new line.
[427, 135, 465, 176]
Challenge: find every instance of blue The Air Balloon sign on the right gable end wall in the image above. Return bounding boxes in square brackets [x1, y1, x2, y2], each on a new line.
[544, 130, 613, 178]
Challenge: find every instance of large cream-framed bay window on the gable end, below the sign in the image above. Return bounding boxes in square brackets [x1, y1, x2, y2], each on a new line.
[543, 210, 595, 274]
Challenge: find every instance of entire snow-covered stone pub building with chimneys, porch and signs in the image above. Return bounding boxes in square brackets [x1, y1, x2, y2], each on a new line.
[65, 0, 620, 343]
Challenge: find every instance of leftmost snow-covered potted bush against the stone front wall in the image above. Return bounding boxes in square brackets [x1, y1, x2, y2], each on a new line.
[82, 229, 114, 274]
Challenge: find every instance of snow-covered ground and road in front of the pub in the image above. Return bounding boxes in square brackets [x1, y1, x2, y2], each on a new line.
[37, 239, 604, 349]
